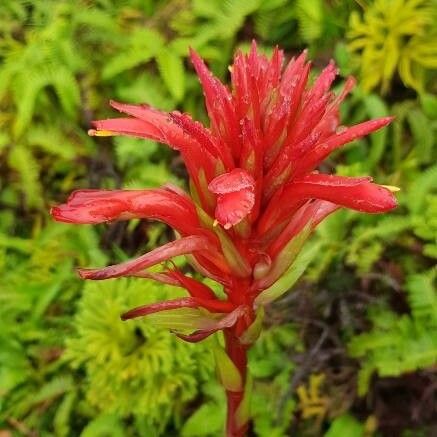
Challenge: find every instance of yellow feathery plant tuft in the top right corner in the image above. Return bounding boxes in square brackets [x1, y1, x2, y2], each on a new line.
[347, 0, 437, 93]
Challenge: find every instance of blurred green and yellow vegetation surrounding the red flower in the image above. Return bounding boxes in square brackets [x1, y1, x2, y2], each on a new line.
[0, 0, 437, 437]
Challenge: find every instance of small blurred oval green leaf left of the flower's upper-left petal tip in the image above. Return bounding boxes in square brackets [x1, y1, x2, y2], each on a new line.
[156, 49, 185, 102]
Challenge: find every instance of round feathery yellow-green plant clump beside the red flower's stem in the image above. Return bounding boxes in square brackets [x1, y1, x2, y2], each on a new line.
[65, 279, 213, 433]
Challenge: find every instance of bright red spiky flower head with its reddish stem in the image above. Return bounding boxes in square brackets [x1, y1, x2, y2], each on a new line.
[52, 43, 396, 436]
